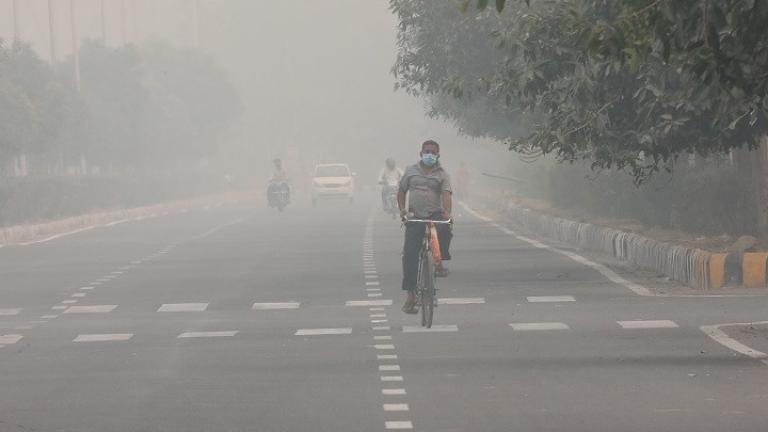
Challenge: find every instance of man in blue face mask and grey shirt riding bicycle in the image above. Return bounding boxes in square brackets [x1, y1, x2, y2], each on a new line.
[397, 140, 453, 314]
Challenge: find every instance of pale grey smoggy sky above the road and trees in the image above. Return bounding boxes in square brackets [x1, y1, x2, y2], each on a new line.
[0, 0, 502, 179]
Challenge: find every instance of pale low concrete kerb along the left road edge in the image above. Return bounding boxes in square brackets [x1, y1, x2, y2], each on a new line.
[0, 195, 240, 246]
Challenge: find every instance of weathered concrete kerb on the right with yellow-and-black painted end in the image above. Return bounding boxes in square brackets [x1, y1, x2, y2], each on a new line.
[500, 202, 768, 290]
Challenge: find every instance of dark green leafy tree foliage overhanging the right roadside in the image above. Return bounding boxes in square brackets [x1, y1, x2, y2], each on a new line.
[390, 0, 768, 181]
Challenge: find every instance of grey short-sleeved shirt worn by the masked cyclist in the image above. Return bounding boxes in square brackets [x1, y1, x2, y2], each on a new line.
[400, 163, 452, 219]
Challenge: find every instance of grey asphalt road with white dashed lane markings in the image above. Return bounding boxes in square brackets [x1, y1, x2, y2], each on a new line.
[0, 194, 768, 432]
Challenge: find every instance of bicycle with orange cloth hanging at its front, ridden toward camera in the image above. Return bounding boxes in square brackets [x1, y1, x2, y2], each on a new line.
[403, 219, 453, 328]
